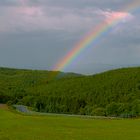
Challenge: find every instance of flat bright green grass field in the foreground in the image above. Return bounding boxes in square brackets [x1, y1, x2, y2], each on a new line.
[0, 106, 140, 140]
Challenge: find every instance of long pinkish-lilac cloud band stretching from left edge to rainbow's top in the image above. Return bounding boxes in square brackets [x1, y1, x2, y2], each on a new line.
[0, 4, 135, 32]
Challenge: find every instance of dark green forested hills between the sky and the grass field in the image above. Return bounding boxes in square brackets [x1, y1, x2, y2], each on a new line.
[0, 67, 140, 117]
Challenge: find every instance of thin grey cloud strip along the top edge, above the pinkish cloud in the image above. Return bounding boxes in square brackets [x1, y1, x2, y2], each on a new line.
[0, 0, 133, 10]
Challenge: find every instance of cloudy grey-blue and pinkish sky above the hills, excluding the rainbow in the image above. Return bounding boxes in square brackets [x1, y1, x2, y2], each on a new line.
[0, 0, 140, 74]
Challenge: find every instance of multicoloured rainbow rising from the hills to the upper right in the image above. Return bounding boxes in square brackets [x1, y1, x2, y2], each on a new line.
[53, 0, 140, 71]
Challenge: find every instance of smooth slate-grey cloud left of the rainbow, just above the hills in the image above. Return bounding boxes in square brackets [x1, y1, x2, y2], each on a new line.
[0, 30, 81, 69]
